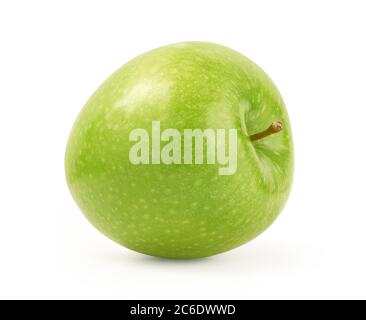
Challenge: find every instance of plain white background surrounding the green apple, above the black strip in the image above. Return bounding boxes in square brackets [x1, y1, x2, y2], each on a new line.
[0, 0, 366, 299]
